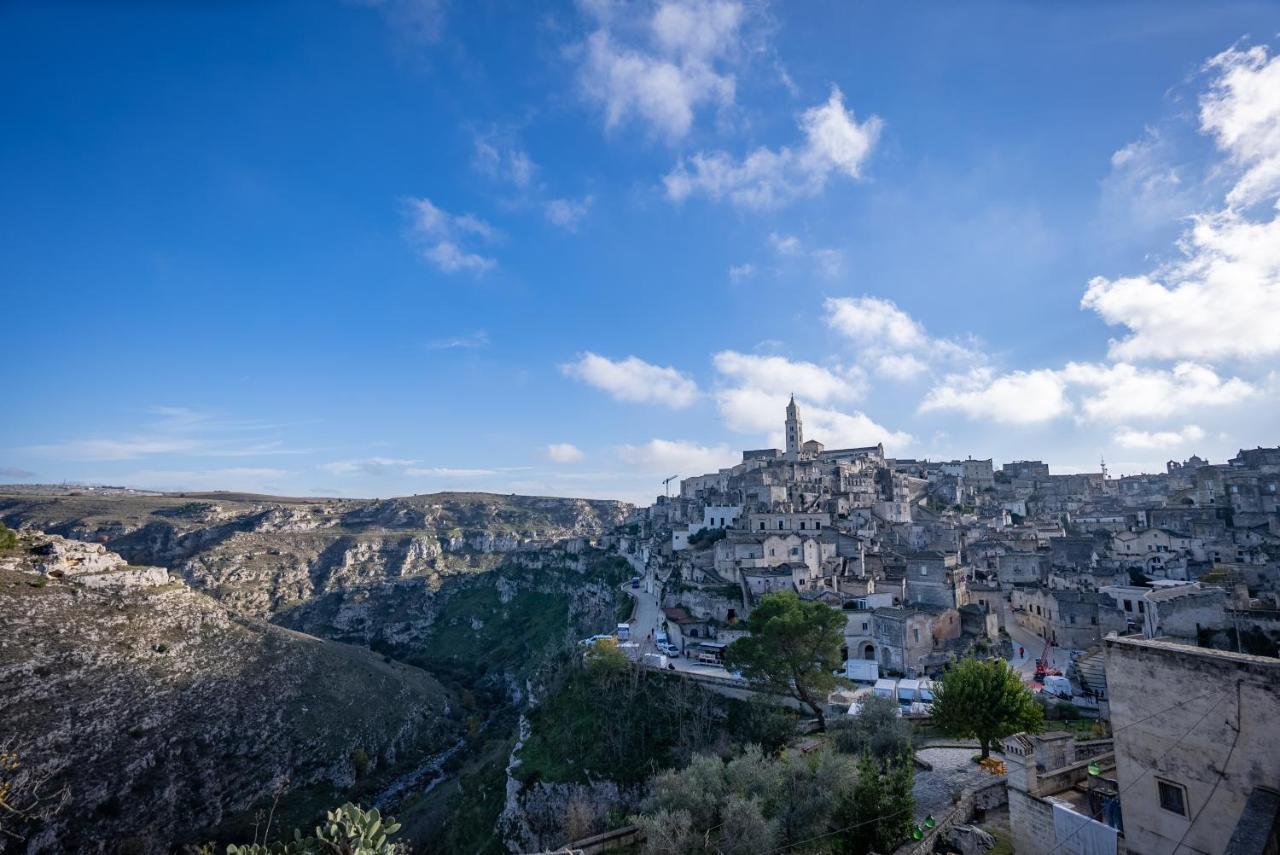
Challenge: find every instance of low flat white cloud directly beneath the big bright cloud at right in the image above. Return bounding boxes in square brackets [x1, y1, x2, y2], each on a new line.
[1061, 362, 1257, 421]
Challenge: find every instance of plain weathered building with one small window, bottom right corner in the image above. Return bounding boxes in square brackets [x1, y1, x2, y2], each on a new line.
[1105, 637, 1280, 855]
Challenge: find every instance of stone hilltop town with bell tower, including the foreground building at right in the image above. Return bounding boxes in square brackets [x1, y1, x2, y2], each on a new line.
[620, 398, 1280, 852]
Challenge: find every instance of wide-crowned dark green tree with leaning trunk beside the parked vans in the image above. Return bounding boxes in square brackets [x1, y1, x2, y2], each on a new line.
[724, 591, 845, 730]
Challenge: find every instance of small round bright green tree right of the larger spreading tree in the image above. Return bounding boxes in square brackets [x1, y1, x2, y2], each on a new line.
[933, 659, 1044, 759]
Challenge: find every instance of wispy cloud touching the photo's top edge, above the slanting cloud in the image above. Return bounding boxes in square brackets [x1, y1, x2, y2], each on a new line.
[579, 0, 744, 142]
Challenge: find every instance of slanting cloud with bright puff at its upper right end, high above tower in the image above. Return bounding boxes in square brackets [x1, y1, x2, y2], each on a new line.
[663, 87, 882, 209]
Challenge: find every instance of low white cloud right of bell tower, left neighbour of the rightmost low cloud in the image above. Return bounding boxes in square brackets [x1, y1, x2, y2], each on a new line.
[919, 369, 1071, 425]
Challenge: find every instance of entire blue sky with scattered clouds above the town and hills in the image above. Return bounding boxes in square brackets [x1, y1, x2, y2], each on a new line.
[0, 0, 1280, 499]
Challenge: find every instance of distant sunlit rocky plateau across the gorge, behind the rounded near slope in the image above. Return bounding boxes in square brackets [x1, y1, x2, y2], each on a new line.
[0, 493, 630, 624]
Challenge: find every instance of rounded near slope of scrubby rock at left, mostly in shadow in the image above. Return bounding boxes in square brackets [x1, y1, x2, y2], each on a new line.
[0, 531, 461, 852]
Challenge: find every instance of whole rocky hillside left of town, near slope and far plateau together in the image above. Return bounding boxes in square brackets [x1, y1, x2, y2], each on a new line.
[0, 491, 630, 851]
